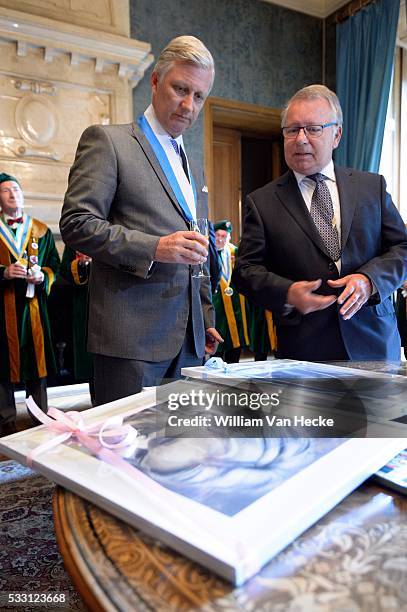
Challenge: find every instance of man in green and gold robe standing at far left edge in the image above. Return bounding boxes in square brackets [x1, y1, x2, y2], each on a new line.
[0, 172, 60, 436]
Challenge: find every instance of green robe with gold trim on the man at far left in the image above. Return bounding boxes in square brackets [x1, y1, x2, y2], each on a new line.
[0, 215, 60, 382]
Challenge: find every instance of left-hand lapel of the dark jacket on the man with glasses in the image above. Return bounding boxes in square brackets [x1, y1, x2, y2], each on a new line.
[276, 170, 329, 257]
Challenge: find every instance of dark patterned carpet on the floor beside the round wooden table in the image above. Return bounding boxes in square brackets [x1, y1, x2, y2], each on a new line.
[0, 461, 87, 612]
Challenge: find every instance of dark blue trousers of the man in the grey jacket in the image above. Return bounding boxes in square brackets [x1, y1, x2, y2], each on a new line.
[93, 323, 203, 406]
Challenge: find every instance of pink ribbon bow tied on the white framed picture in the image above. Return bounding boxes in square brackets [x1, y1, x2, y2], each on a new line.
[26, 397, 137, 467]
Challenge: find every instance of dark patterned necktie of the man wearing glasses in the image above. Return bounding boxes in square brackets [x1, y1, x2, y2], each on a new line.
[307, 172, 341, 261]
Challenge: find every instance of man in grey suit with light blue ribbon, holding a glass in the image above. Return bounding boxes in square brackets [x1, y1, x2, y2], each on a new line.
[60, 36, 221, 405]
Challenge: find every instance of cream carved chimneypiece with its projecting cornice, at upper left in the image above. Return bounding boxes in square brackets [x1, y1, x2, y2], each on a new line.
[0, 0, 153, 234]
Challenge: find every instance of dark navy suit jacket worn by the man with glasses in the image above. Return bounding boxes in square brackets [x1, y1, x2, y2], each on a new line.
[233, 167, 407, 360]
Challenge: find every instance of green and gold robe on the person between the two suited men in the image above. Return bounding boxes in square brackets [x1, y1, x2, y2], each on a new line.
[212, 243, 249, 353]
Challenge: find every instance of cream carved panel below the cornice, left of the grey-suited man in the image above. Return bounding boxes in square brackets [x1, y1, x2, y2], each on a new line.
[0, 72, 112, 231]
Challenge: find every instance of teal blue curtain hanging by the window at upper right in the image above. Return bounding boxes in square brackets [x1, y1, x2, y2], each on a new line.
[335, 0, 400, 172]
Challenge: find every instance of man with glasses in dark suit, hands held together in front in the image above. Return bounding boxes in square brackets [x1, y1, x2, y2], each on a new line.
[233, 85, 407, 361]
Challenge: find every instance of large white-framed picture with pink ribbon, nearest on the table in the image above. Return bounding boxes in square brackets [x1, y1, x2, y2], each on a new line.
[0, 360, 405, 585]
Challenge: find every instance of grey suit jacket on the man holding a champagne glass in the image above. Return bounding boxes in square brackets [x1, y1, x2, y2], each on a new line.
[60, 124, 214, 361]
